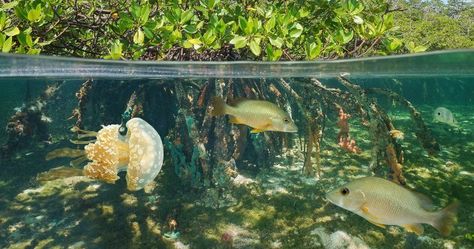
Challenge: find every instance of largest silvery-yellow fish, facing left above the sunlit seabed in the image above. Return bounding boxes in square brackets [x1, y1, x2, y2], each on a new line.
[326, 176, 459, 236]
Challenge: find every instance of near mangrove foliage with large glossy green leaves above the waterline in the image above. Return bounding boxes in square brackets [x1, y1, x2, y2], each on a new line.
[0, 0, 444, 61]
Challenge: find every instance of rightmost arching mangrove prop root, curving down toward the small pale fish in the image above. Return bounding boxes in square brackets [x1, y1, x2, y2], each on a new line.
[366, 88, 440, 155]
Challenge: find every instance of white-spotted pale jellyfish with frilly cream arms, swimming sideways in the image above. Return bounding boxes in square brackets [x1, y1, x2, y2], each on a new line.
[44, 118, 163, 191]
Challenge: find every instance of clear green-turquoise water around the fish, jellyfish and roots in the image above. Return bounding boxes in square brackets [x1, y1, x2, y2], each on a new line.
[0, 50, 474, 248]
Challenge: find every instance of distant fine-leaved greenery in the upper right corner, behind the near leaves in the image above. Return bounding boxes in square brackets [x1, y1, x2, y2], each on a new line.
[396, 0, 474, 52]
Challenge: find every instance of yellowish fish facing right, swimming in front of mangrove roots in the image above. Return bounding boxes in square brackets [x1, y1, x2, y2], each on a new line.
[211, 97, 298, 133]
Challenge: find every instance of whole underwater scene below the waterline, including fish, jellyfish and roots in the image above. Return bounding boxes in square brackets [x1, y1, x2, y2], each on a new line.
[0, 50, 474, 249]
